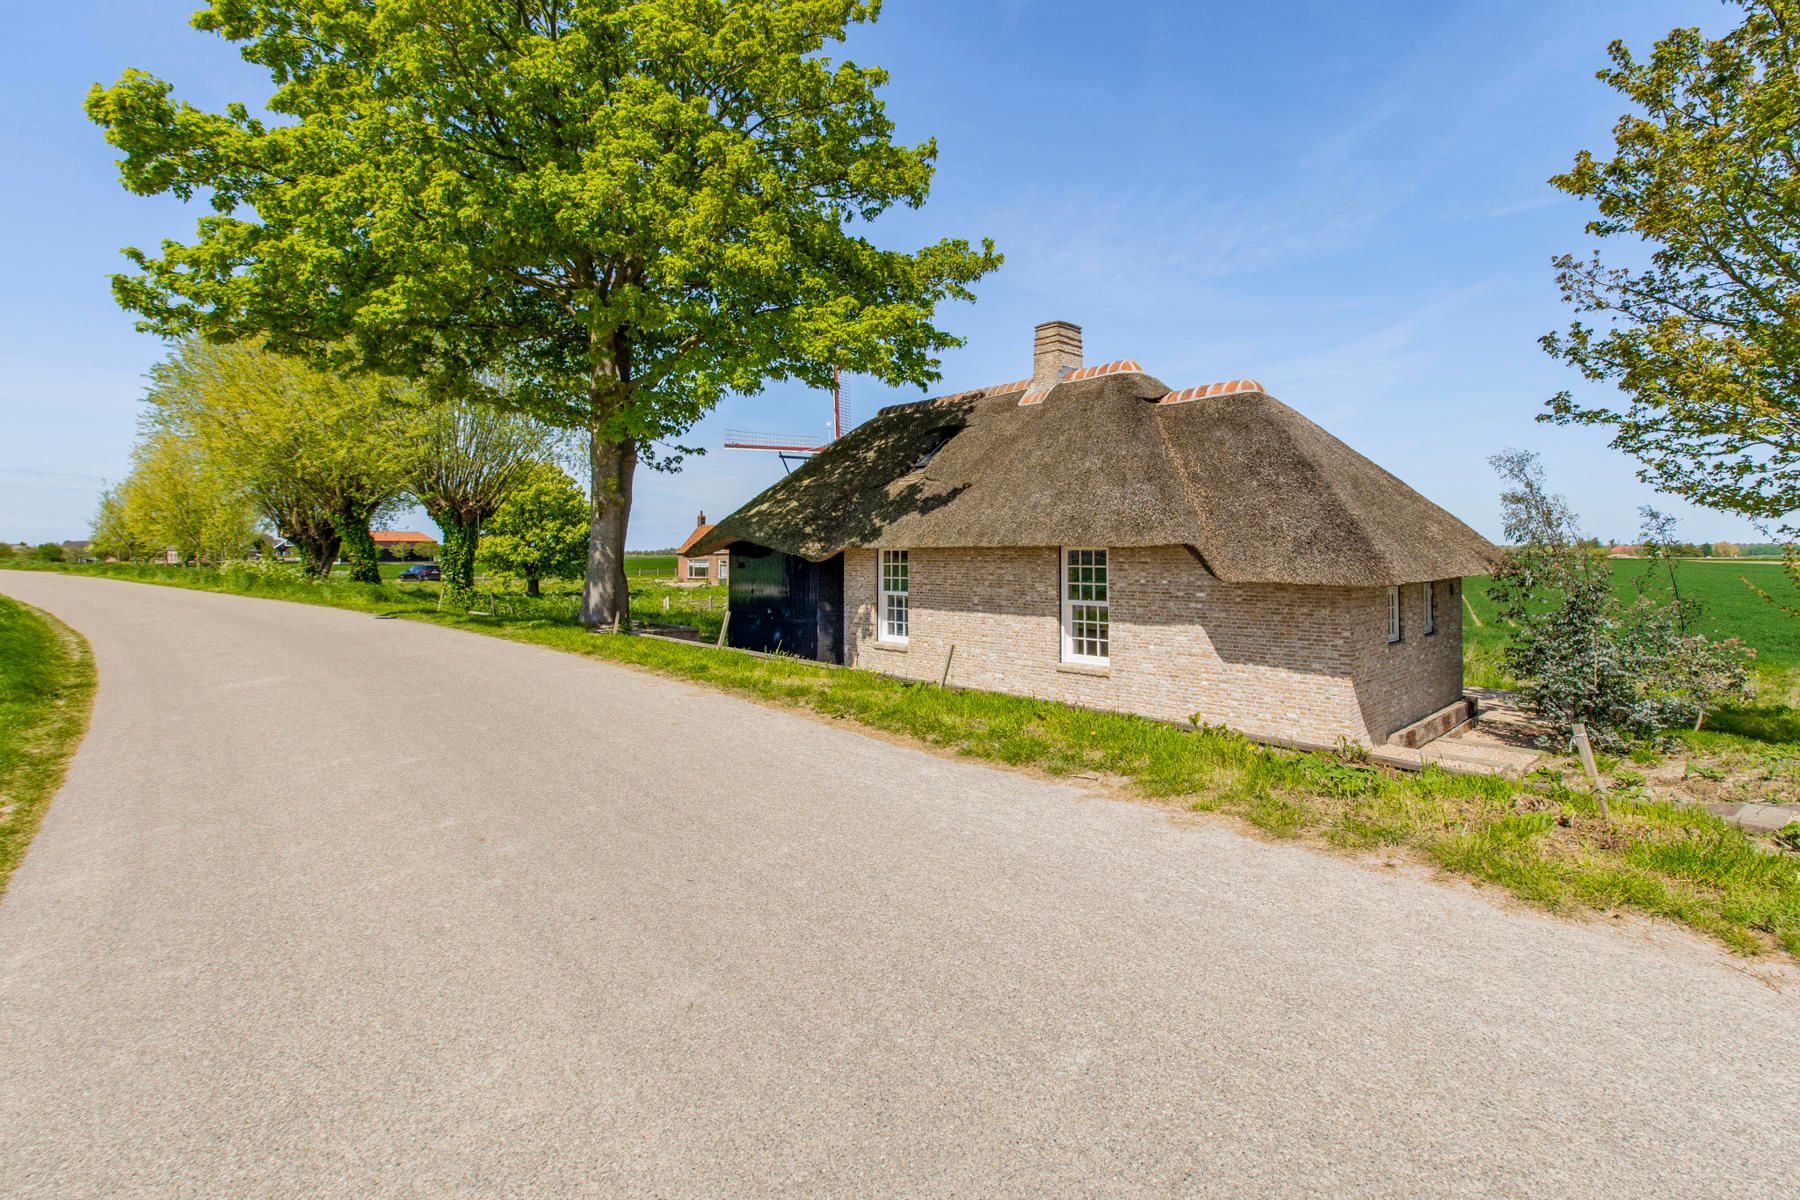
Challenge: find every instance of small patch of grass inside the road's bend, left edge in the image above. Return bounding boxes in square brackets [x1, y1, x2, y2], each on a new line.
[0, 596, 94, 892]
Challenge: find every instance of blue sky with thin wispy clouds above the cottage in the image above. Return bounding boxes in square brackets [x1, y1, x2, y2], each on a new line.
[0, 0, 1760, 549]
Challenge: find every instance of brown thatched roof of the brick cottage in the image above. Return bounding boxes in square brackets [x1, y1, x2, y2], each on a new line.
[689, 362, 1494, 587]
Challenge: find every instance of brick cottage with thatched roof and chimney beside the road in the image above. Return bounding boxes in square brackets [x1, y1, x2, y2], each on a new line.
[682, 322, 1494, 745]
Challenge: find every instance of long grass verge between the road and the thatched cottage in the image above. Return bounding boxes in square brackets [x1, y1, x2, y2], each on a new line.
[10, 567, 1800, 959]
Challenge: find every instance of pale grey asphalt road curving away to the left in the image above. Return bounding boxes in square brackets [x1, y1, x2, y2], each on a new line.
[0, 572, 1800, 1200]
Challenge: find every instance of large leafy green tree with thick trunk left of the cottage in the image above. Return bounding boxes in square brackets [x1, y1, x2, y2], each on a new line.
[86, 0, 999, 622]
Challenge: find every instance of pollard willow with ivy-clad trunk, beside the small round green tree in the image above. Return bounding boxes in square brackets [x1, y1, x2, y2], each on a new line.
[407, 399, 556, 592]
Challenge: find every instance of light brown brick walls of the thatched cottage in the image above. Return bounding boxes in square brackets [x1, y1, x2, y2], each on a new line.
[844, 547, 1462, 745]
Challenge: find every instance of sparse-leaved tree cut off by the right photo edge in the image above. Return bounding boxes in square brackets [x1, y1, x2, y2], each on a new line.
[1543, 0, 1800, 527]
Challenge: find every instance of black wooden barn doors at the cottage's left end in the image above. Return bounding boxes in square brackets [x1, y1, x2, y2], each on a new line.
[725, 545, 844, 662]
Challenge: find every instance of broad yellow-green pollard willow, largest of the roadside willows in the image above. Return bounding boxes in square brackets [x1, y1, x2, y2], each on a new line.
[149, 338, 421, 583]
